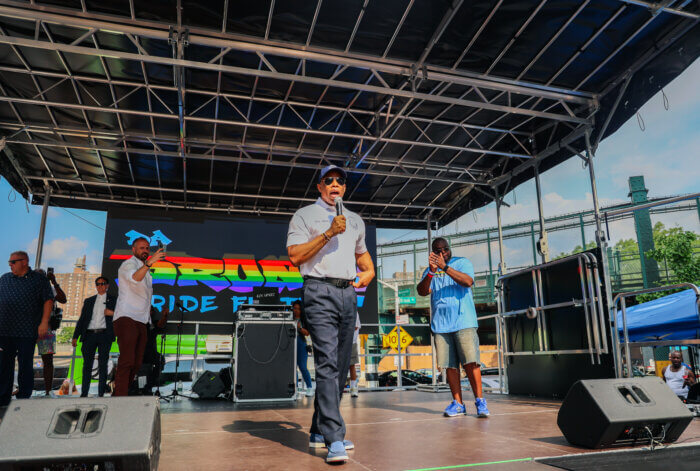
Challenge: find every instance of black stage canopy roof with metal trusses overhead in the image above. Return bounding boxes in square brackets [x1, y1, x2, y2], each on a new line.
[0, 0, 700, 228]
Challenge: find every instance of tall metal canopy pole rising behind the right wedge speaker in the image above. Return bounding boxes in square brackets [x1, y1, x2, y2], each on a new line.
[585, 129, 622, 378]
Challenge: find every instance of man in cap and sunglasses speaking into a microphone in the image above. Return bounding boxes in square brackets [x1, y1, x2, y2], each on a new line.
[287, 165, 374, 463]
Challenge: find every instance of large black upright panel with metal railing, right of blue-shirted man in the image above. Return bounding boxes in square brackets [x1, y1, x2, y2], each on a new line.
[499, 249, 615, 398]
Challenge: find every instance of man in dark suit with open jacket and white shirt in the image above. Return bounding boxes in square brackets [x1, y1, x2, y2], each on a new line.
[73, 276, 117, 397]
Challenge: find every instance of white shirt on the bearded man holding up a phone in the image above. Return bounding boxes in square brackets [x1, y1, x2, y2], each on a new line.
[113, 256, 153, 324]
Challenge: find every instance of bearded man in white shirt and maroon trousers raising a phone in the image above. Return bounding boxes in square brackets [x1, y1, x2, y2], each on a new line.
[112, 237, 165, 396]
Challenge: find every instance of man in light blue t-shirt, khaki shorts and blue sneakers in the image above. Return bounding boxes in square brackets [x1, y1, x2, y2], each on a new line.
[417, 237, 489, 417]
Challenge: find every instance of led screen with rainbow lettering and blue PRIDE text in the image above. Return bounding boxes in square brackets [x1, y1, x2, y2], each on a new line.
[102, 209, 377, 334]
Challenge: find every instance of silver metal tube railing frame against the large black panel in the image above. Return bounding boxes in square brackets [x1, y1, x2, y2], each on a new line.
[497, 252, 609, 364]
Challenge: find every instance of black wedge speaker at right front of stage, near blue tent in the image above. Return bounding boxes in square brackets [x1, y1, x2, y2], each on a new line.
[557, 376, 693, 448]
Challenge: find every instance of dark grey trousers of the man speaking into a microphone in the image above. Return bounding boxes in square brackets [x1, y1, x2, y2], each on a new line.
[302, 280, 357, 444]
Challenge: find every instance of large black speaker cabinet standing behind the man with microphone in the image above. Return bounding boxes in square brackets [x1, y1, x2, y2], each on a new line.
[233, 320, 297, 402]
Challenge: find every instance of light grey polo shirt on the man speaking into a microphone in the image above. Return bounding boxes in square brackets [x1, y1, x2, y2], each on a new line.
[287, 198, 367, 280]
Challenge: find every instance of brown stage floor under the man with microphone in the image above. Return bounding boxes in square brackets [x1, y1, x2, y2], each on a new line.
[160, 391, 700, 471]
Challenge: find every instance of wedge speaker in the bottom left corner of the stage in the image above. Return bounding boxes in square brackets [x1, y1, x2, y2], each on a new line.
[0, 397, 160, 471]
